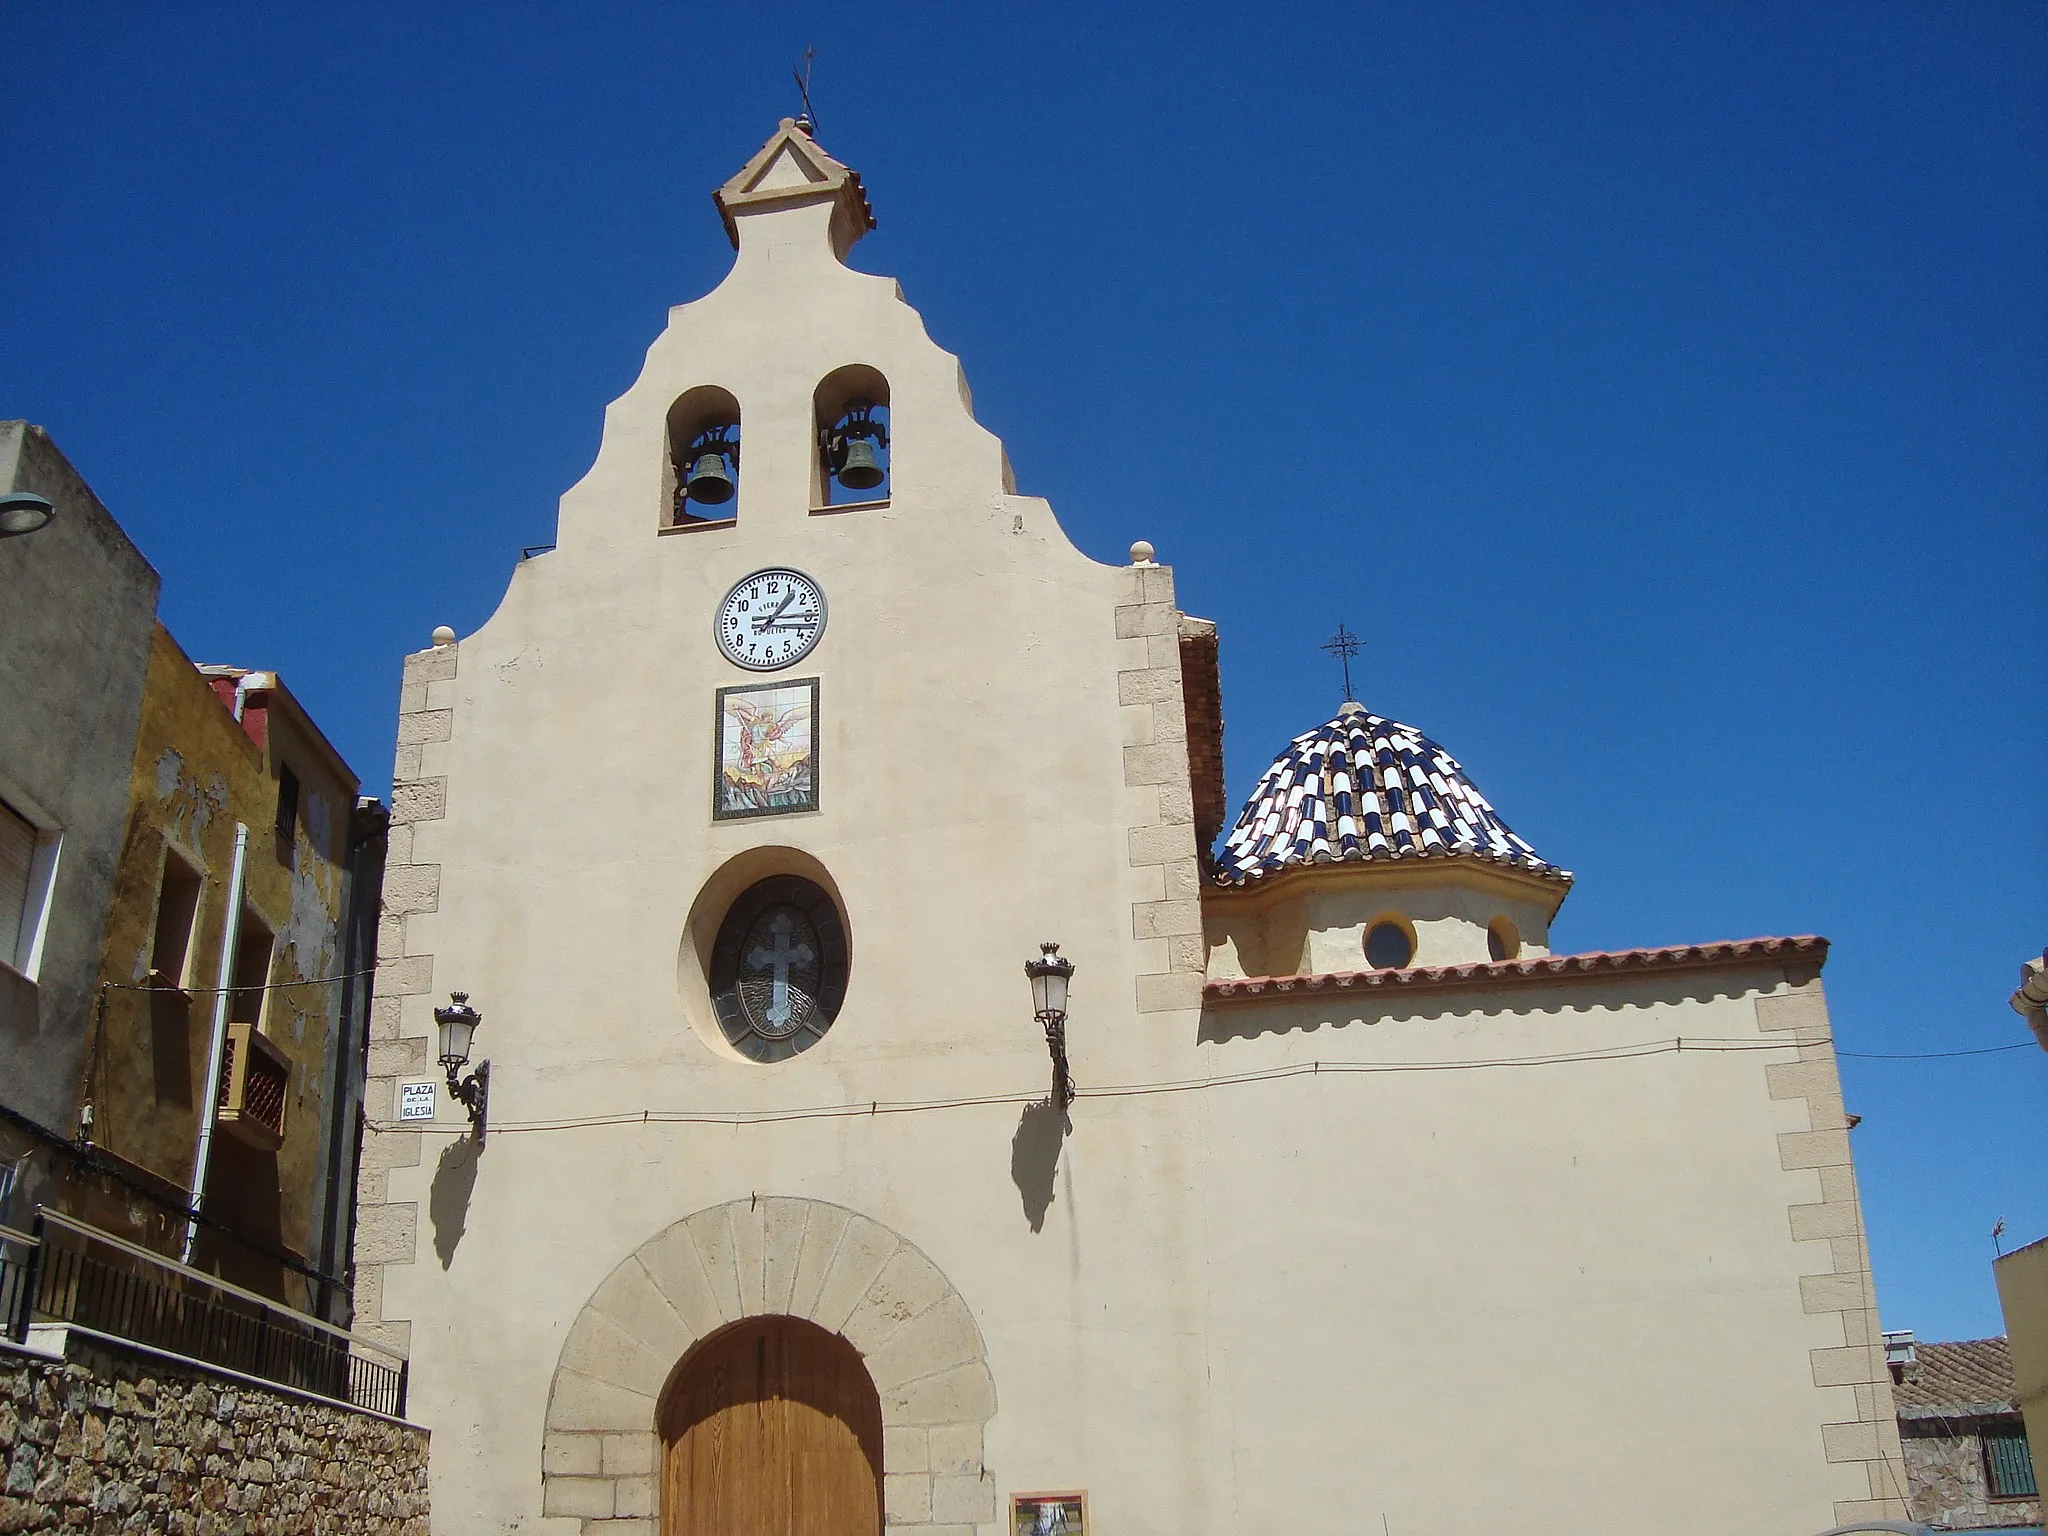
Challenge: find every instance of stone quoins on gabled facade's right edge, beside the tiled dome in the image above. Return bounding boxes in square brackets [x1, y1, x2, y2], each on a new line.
[1116, 563, 1208, 1014]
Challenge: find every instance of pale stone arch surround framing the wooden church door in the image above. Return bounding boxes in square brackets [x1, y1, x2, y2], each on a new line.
[541, 1196, 995, 1536]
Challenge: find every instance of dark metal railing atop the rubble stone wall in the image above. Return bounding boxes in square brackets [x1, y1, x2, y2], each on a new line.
[0, 1210, 410, 1419]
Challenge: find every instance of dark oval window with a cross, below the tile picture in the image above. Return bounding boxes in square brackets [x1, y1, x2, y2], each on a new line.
[711, 874, 846, 1061]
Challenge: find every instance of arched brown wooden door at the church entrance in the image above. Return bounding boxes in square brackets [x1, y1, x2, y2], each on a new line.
[662, 1317, 883, 1536]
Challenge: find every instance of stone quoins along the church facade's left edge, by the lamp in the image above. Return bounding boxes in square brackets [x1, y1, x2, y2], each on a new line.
[354, 645, 459, 1350]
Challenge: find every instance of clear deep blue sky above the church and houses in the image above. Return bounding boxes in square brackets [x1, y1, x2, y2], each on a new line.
[0, 0, 2048, 1337]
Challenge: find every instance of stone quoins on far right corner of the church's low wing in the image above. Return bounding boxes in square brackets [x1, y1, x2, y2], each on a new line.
[1757, 977, 1907, 1524]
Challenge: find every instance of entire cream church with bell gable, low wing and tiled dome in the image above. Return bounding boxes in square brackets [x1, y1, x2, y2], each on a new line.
[356, 123, 1905, 1536]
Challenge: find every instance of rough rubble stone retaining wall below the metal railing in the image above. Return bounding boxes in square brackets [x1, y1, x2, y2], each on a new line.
[0, 1335, 428, 1536]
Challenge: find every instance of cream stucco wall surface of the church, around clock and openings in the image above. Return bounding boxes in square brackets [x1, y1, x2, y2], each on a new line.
[356, 129, 1888, 1536]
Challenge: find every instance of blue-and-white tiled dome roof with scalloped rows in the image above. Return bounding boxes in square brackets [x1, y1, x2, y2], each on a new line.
[1217, 705, 1571, 885]
